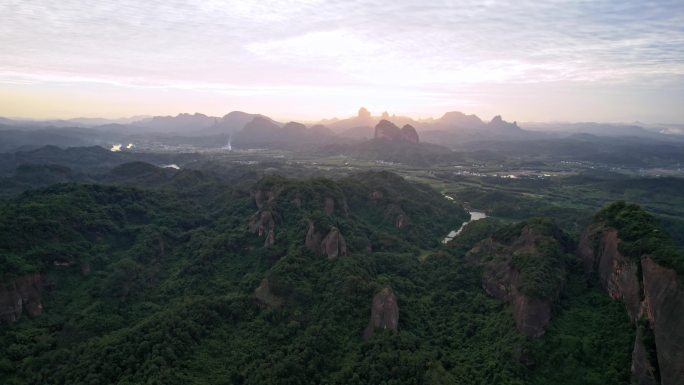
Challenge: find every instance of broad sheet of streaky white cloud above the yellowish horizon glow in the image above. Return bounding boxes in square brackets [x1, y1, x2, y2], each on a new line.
[0, 0, 684, 120]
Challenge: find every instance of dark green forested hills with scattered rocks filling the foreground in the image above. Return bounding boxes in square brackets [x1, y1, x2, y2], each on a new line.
[0, 163, 680, 384]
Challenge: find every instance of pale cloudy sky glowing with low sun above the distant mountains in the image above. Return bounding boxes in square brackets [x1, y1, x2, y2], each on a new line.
[0, 0, 684, 123]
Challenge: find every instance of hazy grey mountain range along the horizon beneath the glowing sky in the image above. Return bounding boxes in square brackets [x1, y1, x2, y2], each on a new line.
[0, 107, 684, 160]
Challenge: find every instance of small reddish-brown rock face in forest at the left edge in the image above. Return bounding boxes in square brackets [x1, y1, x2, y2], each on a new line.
[0, 274, 43, 322]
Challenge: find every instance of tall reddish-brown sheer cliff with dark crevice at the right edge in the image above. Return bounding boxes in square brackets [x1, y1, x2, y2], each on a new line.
[578, 226, 684, 385]
